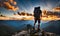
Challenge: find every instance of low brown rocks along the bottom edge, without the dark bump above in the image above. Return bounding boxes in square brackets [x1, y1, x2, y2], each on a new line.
[12, 30, 60, 36]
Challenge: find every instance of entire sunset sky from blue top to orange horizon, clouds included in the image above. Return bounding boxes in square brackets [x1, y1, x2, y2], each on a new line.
[0, 0, 60, 20]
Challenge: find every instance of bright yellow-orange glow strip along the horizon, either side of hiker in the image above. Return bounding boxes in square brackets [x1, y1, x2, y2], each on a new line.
[0, 15, 60, 21]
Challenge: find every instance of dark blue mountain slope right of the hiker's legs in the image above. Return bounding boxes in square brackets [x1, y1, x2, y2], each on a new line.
[43, 20, 60, 34]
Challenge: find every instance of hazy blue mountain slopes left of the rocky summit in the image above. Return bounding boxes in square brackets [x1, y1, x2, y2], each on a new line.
[0, 20, 26, 36]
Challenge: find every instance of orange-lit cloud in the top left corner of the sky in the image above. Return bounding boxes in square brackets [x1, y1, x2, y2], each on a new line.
[0, 0, 19, 11]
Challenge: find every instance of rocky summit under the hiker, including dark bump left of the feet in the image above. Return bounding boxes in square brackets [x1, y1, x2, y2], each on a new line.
[12, 25, 60, 36]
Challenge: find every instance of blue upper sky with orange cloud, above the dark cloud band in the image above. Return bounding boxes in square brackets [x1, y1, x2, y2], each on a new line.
[0, 0, 60, 16]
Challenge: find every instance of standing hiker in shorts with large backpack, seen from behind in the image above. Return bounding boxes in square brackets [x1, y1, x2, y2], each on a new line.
[34, 7, 42, 30]
